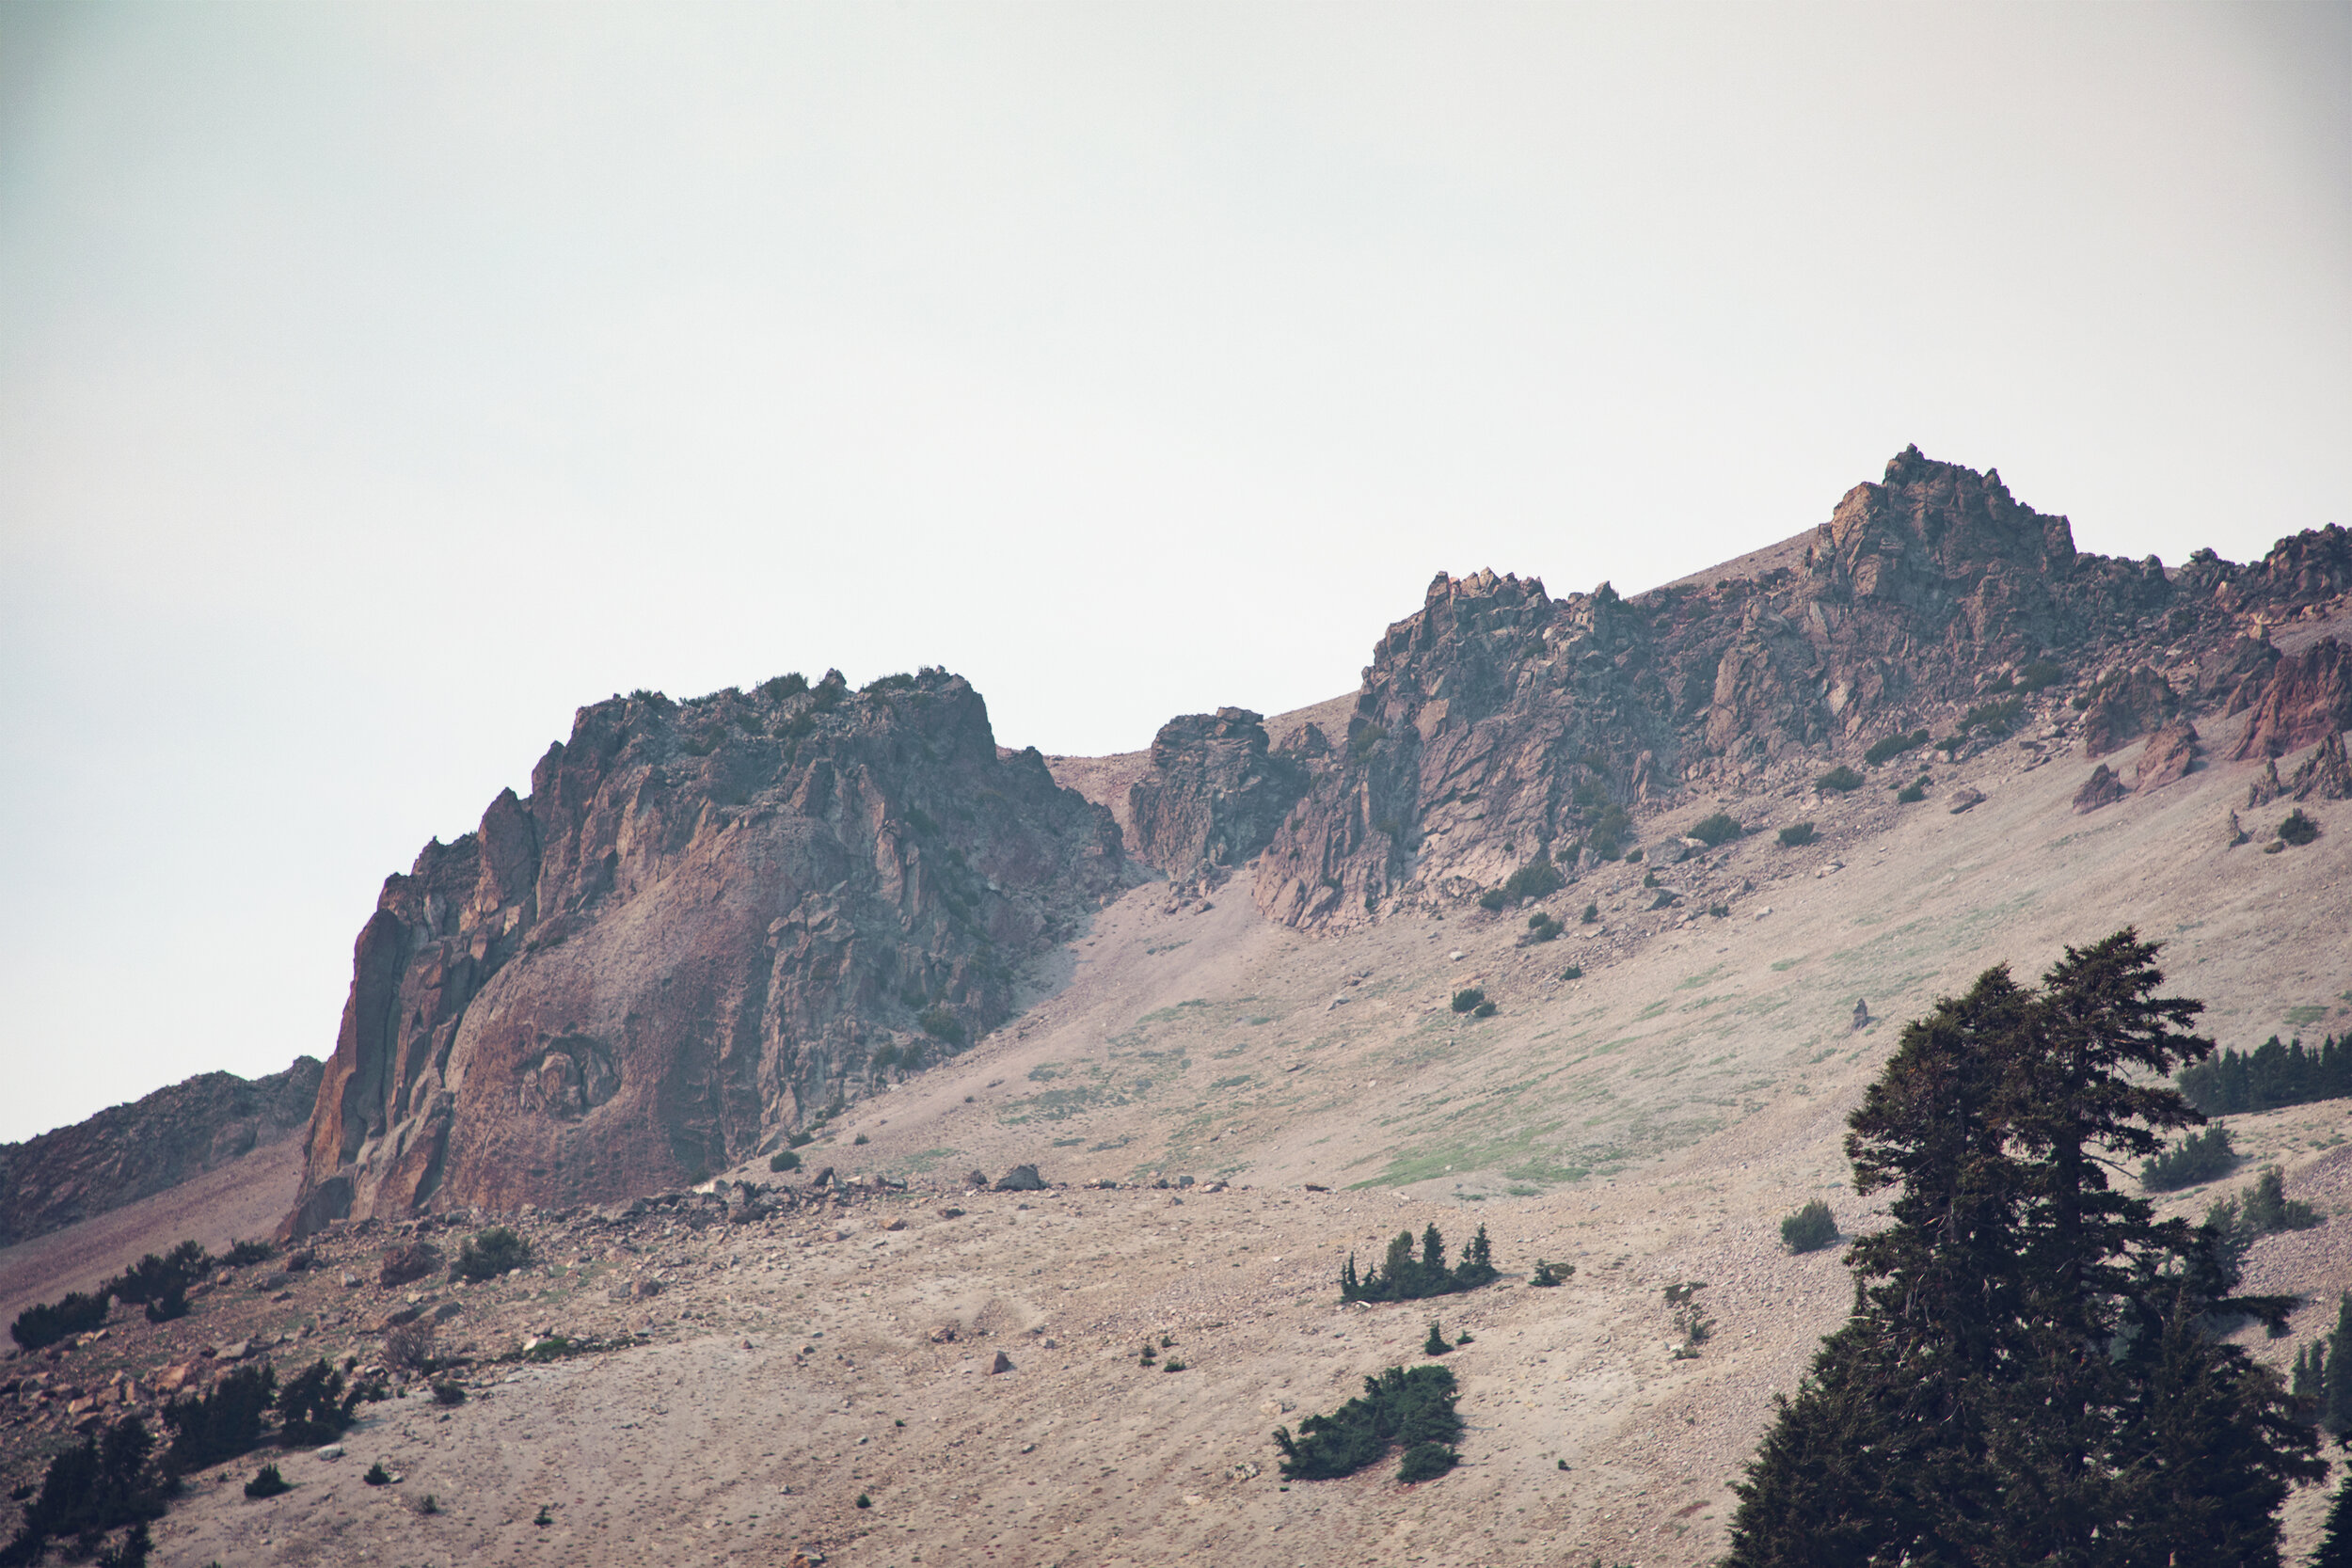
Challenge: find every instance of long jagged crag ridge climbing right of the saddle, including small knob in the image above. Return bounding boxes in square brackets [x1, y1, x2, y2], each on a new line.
[1105, 449, 2352, 928]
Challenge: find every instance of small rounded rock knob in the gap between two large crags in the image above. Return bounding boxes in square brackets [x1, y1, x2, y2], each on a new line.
[1127, 707, 1327, 877]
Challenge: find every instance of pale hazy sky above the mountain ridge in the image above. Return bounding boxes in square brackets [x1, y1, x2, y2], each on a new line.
[0, 0, 2352, 1138]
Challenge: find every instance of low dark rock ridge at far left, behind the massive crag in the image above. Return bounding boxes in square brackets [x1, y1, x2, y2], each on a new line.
[0, 1055, 320, 1246]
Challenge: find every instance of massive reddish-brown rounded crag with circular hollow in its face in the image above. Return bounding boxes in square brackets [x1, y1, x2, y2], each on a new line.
[290, 670, 1122, 1232]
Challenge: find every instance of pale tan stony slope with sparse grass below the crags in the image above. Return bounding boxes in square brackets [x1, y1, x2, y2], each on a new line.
[0, 705, 2352, 1568]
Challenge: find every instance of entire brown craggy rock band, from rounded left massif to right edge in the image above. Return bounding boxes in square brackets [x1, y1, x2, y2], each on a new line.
[270, 449, 2352, 1229]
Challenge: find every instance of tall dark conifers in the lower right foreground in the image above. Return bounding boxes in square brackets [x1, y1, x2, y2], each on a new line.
[1726, 931, 2327, 1568]
